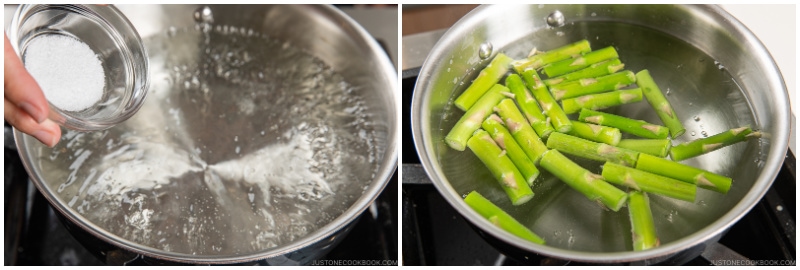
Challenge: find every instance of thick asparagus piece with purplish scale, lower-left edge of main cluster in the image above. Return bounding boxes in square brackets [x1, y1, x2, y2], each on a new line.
[467, 129, 533, 205]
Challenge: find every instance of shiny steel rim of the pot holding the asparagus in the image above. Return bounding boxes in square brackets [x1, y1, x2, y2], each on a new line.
[411, 5, 791, 263]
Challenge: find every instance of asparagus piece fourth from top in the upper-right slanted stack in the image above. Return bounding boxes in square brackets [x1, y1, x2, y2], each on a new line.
[550, 70, 636, 100]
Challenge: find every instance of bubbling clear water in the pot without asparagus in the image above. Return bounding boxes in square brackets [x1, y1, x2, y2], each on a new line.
[39, 24, 385, 255]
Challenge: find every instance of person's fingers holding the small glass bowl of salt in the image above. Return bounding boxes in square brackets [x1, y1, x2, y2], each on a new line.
[3, 34, 61, 147]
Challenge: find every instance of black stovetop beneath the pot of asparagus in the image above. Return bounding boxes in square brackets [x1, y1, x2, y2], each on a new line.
[401, 77, 796, 265]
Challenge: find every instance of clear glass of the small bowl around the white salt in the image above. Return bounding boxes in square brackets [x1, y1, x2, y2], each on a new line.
[7, 5, 149, 131]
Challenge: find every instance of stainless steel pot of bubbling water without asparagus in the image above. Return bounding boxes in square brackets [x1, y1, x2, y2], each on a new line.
[15, 5, 399, 264]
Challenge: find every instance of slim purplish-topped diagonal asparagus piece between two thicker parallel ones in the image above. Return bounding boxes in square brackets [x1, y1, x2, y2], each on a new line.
[483, 114, 539, 186]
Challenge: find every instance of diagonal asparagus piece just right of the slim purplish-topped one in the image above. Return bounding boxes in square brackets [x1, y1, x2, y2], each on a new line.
[495, 98, 547, 163]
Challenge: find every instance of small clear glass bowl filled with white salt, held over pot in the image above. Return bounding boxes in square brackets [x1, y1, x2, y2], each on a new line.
[7, 5, 149, 131]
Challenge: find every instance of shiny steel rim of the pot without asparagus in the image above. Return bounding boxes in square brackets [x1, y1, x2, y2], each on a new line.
[14, 5, 400, 264]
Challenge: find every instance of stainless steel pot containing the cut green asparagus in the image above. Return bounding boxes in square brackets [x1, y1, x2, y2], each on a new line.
[411, 5, 790, 263]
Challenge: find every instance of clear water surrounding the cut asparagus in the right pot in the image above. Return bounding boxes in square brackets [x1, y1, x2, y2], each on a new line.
[438, 21, 765, 252]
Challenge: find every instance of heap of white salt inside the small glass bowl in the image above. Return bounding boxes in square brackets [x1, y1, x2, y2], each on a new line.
[24, 35, 106, 111]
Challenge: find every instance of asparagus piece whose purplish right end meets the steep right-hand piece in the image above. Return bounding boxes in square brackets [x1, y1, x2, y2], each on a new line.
[578, 109, 669, 139]
